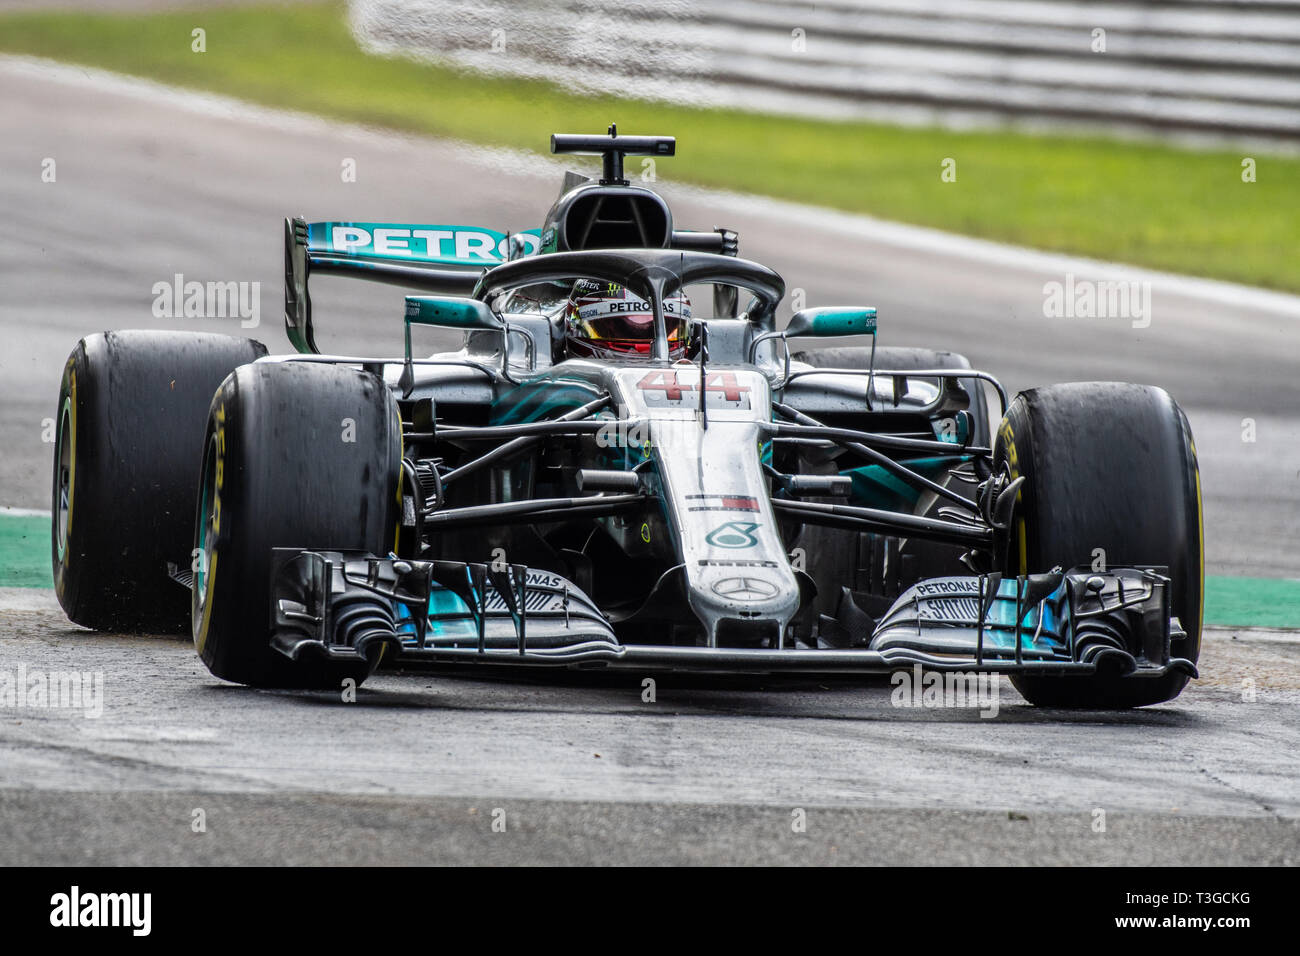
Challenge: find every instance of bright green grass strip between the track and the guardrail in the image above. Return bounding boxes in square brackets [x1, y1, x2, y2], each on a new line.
[0, 4, 1300, 290]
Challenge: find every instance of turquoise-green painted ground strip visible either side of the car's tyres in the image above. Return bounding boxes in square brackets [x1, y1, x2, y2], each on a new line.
[0, 514, 1300, 628]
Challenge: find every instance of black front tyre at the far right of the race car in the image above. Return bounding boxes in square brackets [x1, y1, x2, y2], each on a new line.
[995, 382, 1205, 709]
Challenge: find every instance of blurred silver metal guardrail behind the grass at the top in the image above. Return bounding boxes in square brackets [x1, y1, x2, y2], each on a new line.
[350, 0, 1300, 140]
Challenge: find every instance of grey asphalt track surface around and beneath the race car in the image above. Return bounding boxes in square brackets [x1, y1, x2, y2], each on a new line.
[0, 64, 1300, 864]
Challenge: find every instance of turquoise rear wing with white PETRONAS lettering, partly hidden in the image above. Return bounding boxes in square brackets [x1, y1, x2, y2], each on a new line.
[285, 219, 542, 354]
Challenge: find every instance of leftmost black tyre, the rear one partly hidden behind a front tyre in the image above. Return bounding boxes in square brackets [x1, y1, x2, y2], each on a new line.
[51, 332, 267, 633]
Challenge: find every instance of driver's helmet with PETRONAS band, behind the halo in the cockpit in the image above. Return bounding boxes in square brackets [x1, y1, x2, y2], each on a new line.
[564, 278, 690, 359]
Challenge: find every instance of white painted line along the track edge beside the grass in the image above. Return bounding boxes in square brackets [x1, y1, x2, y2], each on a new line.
[0, 55, 1300, 319]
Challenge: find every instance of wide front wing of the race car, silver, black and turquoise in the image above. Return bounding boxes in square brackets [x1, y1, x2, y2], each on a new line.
[270, 549, 1196, 679]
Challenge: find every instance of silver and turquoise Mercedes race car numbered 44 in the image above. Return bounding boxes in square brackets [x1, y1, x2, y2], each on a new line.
[52, 127, 1203, 708]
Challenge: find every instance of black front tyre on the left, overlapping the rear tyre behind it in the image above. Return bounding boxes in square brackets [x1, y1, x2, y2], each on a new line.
[192, 362, 402, 688]
